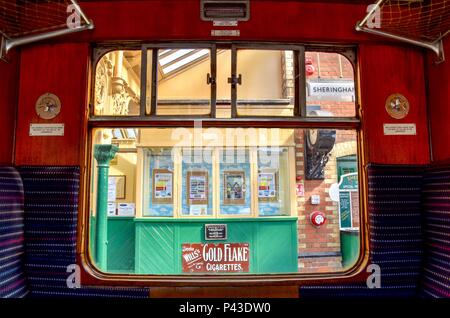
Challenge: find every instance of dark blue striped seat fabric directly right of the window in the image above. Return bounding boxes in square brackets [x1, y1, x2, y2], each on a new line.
[300, 165, 424, 297]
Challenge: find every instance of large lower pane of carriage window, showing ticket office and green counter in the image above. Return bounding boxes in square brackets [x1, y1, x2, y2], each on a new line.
[91, 128, 360, 274]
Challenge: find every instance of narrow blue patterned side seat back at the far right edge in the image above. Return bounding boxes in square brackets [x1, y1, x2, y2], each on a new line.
[422, 166, 450, 297]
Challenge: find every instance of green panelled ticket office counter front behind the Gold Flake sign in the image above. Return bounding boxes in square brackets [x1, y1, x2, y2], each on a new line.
[91, 217, 298, 275]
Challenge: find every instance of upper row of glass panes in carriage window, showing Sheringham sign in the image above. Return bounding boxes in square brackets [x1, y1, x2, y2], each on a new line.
[93, 46, 356, 118]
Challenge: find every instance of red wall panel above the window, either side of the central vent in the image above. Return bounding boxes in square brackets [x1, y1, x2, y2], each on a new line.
[76, 0, 370, 42]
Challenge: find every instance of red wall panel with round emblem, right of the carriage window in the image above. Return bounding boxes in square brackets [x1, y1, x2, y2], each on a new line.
[359, 45, 430, 164]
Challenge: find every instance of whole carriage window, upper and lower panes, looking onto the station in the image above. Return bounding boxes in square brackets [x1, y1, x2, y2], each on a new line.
[87, 45, 363, 280]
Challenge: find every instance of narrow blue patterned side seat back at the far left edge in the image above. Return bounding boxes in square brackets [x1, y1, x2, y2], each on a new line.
[0, 167, 28, 298]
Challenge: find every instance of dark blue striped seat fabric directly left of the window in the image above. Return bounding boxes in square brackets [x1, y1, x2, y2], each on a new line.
[19, 167, 149, 298]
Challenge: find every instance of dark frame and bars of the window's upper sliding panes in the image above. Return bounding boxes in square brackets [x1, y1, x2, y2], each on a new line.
[89, 42, 359, 124]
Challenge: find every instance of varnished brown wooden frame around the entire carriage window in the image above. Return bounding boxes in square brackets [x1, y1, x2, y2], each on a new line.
[81, 42, 369, 287]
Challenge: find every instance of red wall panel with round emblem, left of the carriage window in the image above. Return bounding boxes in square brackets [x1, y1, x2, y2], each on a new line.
[15, 43, 89, 166]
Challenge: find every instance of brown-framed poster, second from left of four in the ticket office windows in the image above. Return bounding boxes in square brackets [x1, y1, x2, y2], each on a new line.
[186, 171, 209, 205]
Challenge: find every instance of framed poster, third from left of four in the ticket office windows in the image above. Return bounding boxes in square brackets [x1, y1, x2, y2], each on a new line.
[223, 170, 245, 205]
